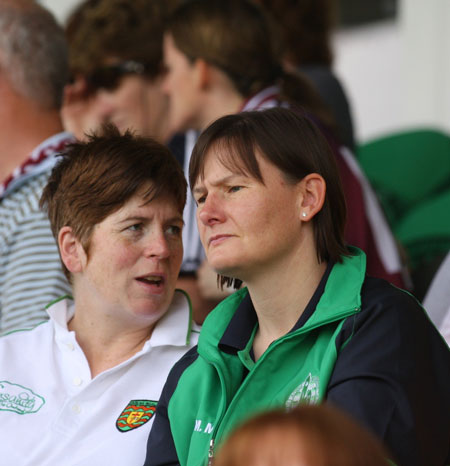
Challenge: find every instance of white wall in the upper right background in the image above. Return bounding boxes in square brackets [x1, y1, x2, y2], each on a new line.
[335, 0, 450, 142]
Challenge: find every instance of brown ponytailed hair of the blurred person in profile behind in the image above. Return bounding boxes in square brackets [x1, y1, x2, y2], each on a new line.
[166, 0, 335, 131]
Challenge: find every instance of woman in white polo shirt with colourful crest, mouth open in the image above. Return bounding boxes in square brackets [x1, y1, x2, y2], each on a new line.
[0, 127, 197, 466]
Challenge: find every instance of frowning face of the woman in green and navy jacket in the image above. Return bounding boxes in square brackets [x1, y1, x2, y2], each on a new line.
[193, 147, 302, 282]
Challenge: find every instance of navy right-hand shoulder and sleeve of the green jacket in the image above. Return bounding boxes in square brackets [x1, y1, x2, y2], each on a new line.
[327, 277, 450, 466]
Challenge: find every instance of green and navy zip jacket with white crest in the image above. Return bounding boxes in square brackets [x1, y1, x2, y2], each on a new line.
[145, 250, 450, 466]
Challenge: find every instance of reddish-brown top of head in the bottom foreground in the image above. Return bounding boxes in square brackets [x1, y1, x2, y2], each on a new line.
[213, 404, 390, 466]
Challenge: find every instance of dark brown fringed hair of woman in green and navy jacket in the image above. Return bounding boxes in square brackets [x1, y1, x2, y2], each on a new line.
[189, 107, 348, 286]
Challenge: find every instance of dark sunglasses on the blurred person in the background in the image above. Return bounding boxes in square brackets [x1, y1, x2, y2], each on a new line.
[81, 60, 149, 92]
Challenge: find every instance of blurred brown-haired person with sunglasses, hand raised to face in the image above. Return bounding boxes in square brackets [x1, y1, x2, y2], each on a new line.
[62, 0, 216, 324]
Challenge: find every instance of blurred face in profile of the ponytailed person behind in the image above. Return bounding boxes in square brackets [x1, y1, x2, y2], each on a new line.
[163, 34, 201, 133]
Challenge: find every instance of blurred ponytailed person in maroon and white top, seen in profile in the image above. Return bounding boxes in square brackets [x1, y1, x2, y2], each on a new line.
[163, 0, 406, 294]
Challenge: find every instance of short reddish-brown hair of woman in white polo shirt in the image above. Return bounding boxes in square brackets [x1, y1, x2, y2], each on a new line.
[40, 125, 187, 279]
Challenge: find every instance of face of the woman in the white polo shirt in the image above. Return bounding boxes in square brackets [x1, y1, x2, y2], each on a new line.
[75, 189, 183, 324]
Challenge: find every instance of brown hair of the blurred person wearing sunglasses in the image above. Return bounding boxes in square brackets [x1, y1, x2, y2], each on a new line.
[66, 0, 178, 78]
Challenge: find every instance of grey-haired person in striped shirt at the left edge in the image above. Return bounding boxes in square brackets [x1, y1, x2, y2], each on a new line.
[0, 0, 73, 334]
